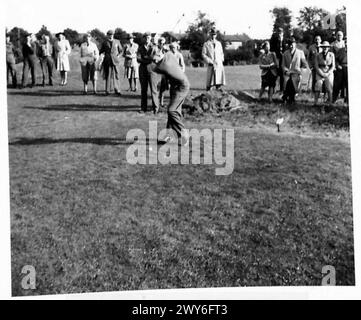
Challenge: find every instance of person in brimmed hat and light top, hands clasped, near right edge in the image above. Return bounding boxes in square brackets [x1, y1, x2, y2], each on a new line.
[315, 41, 335, 105]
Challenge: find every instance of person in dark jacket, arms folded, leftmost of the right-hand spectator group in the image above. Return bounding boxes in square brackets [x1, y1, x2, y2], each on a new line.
[259, 41, 278, 102]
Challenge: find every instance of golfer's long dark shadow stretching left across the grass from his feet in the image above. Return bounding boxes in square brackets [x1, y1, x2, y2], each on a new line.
[9, 137, 164, 146]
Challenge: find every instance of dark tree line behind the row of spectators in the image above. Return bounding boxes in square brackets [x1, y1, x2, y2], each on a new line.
[7, 6, 346, 66]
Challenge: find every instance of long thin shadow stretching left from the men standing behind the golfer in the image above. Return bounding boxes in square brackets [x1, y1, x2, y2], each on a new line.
[23, 103, 140, 112]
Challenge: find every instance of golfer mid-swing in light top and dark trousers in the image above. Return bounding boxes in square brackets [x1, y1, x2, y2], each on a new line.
[152, 51, 190, 144]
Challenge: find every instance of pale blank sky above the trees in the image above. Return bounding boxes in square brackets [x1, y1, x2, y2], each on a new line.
[1, 0, 349, 38]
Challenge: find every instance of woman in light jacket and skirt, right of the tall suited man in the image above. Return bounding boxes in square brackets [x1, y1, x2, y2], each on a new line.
[123, 34, 139, 91]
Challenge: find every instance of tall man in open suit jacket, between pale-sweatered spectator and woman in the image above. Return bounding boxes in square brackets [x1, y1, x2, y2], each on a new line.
[99, 30, 123, 95]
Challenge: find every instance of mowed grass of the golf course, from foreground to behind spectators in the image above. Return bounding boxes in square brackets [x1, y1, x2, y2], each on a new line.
[8, 48, 355, 295]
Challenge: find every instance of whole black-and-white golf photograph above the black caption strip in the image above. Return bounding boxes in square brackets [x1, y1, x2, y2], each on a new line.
[1, 0, 359, 297]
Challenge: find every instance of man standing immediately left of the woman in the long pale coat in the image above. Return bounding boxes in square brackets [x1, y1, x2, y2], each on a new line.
[38, 34, 54, 87]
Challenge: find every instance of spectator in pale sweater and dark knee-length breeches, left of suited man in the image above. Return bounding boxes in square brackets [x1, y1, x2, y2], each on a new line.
[80, 33, 99, 94]
